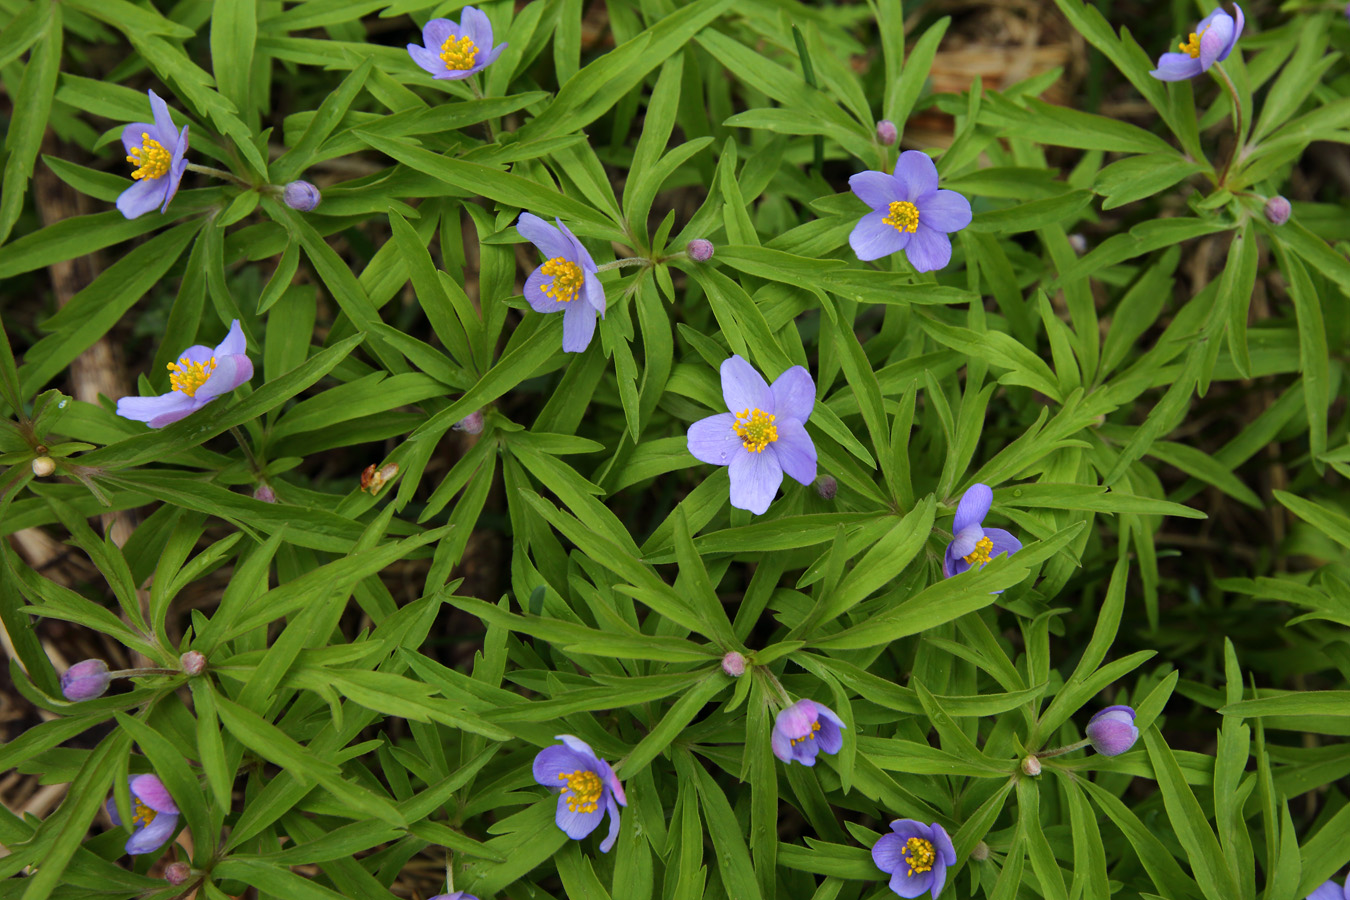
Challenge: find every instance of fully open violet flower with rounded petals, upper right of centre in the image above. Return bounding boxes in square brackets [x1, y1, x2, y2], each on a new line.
[848, 150, 971, 271]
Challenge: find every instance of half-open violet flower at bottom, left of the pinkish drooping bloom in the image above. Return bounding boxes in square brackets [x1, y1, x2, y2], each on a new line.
[535, 734, 628, 853]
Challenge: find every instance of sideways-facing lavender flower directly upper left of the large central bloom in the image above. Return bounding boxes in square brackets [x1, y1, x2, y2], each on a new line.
[513, 214, 605, 354]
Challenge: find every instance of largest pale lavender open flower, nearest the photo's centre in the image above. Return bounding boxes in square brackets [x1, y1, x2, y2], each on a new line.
[687, 356, 815, 515]
